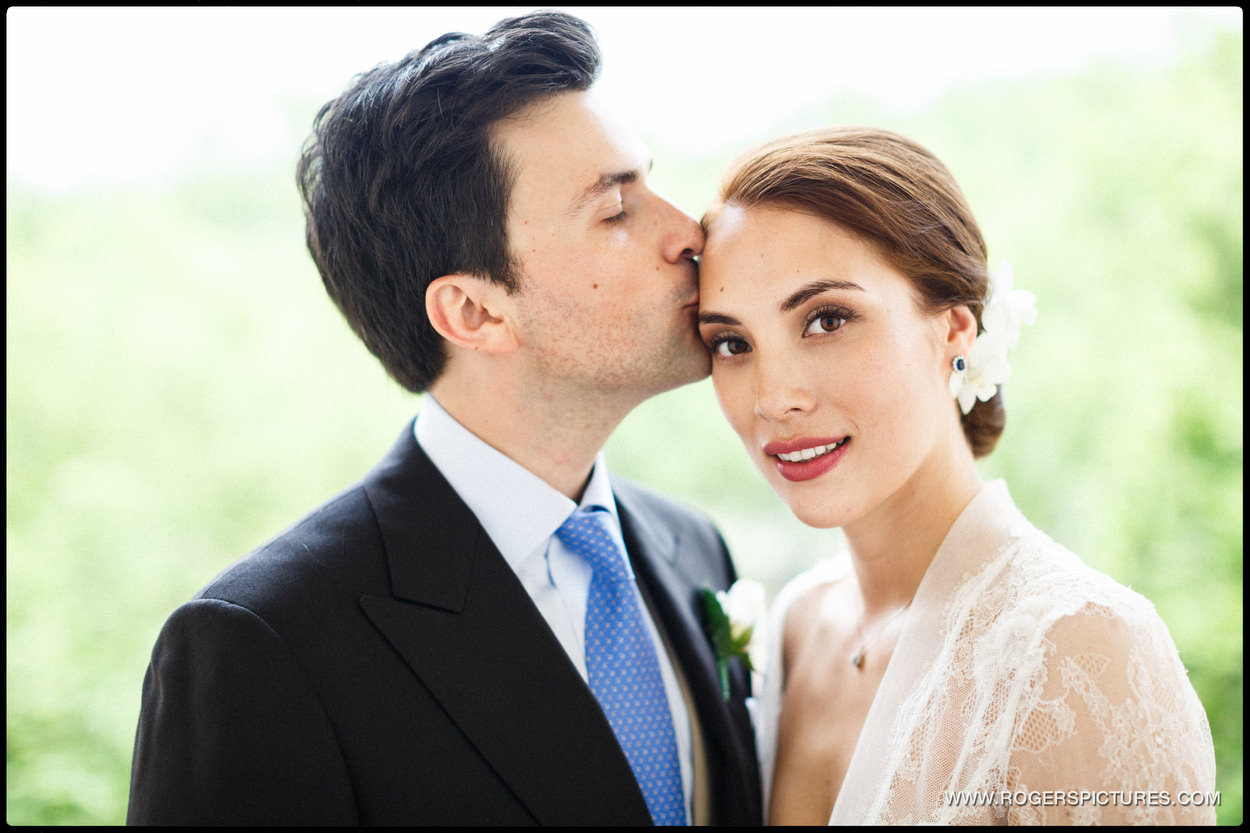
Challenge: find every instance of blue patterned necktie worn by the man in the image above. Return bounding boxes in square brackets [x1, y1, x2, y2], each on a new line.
[555, 508, 686, 824]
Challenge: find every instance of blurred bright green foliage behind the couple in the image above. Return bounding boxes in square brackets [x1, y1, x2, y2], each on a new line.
[6, 11, 1243, 824]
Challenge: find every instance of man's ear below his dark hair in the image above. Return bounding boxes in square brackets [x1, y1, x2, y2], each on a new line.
[425, 273, 518, 353]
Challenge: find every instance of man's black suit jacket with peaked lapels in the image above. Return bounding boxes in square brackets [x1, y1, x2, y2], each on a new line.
[128, 417, 761, 824]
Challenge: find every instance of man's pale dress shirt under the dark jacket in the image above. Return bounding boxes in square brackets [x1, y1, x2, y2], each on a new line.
[414, 393, 694, 823]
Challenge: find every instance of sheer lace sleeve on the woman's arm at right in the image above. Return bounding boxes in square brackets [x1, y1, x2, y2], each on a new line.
[1006, 603, 1215, 824]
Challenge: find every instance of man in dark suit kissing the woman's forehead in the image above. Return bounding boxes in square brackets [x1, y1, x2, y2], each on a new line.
[129, 13, 760, 824]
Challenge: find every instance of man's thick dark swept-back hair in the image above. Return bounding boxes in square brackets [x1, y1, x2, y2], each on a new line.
[296, 11, 600, 393]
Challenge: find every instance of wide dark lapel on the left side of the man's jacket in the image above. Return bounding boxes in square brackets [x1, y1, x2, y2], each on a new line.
[361, 430, 651, 824]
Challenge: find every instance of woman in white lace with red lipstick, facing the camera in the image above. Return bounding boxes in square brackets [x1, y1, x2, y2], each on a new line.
[699, 129, 1215, 824]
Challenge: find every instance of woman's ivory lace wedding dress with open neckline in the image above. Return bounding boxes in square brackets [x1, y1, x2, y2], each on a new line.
[759, 480, 1215, 824]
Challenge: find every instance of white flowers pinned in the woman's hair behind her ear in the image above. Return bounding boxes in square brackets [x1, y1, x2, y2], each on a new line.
[950, 260, 1038, 414]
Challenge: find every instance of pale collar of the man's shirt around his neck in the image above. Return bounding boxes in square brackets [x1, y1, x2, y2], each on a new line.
[413, 393, 620, 569]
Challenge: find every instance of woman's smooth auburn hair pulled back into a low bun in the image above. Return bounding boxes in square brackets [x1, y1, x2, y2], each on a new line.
[704, 128, 1006, 457]
